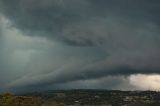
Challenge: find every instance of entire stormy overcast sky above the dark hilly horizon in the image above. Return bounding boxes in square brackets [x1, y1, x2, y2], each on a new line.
[0, 0, 160, 92]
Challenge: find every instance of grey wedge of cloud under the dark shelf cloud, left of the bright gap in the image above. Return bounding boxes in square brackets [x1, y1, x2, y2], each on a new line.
[52, 76, 135, 90]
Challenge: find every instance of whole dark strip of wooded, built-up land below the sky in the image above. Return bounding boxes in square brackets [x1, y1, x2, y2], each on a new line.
[0, 90, 160, 106]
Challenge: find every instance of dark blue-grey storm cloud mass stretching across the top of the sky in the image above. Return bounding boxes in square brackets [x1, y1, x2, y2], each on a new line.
[1, 0, 160, 45]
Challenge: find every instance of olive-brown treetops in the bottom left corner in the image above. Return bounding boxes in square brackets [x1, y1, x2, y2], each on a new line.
[0, 93, 65, 106]
